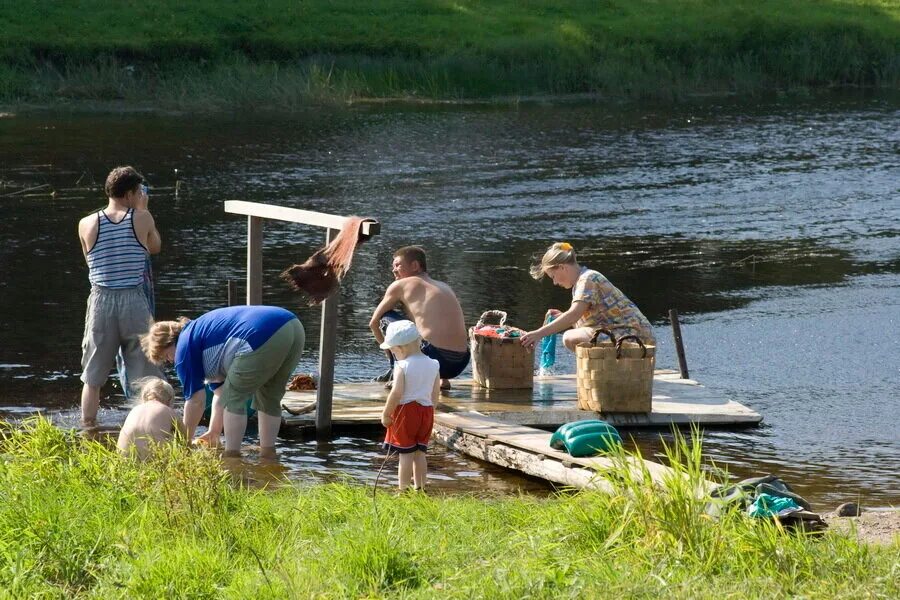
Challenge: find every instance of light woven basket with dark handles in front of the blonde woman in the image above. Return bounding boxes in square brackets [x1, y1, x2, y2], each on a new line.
[575, 329, 656, 413]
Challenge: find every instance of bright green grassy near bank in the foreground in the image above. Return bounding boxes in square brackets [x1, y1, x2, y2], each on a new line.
[0, 421, 900, 598]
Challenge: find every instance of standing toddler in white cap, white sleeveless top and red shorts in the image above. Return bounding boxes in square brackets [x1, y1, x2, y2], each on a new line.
[381, 321, 441, 491]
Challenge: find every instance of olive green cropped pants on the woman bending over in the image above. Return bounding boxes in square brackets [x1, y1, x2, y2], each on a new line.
[219, 319, 306, 417]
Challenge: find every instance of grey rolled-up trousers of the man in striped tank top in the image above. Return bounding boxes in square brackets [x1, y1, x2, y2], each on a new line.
[81, 285, 163, 387]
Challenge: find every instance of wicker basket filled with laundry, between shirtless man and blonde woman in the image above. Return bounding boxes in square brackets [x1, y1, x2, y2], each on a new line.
[469, 310, 534, 390]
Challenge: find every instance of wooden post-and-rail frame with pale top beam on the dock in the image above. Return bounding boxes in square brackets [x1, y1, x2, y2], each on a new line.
[225, 200, 381, 438]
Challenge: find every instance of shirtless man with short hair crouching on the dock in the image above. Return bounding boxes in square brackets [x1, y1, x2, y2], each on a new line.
[369, 246, 469, 390]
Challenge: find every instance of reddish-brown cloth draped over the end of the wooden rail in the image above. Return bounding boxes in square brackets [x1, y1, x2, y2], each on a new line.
[281, 217, 372, 306]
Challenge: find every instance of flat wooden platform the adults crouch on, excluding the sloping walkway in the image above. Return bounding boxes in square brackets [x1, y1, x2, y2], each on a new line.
[282, 370, 762, 428]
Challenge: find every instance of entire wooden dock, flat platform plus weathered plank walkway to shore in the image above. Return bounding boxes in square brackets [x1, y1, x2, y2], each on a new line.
[282, 370, 748, 492]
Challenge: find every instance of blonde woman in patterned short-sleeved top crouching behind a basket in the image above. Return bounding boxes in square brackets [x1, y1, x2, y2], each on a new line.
[522, 242, 656, 352]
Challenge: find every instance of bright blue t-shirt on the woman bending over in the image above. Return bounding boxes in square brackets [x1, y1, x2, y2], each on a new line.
[175, 306, 297, 399]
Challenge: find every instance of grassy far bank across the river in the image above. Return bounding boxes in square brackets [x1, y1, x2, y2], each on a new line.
[0, 0, 900, 109]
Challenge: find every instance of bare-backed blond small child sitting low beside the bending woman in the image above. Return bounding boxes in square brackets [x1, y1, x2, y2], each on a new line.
[117, 377, 187, 460]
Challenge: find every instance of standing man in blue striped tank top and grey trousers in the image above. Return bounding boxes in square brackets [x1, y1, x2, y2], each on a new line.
[78, 167, 162, 425]
